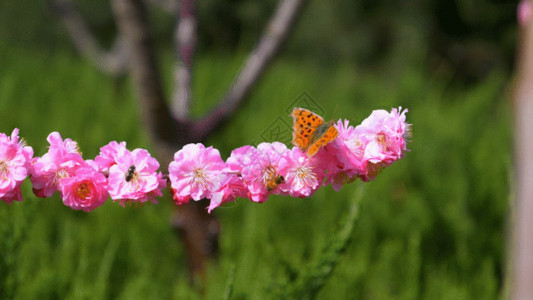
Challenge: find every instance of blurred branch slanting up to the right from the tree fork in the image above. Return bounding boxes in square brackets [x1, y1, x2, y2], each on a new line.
[195, 0, 305, 140]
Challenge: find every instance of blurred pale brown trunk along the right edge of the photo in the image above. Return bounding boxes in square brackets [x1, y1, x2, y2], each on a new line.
[510, 11, 533, 299]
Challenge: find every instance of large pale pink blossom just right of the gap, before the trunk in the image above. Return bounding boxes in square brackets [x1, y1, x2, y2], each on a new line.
[168, 144, 225, 204]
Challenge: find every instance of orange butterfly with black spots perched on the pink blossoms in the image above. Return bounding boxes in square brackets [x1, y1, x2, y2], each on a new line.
[291, 107, 339, 157]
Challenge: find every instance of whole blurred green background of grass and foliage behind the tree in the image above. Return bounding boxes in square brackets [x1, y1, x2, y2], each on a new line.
[0, 0, 518, 299]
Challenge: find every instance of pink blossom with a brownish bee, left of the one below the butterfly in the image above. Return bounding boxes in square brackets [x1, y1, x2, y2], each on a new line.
[241, 142, 288, 203]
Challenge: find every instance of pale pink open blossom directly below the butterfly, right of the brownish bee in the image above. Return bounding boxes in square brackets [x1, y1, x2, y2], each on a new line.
[279, 147, 324, 198]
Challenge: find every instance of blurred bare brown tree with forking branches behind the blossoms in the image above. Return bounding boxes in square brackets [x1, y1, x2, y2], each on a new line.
[55, 0, 305, 279]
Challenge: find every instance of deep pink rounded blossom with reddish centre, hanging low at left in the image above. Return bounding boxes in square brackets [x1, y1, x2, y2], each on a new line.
[59, 166, 108, 212]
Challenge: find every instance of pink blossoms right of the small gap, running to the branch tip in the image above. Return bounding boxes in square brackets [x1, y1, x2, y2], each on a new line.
[169, 108, 411, 212]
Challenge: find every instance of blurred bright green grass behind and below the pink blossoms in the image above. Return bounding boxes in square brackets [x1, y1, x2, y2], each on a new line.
[0, 43, 511, 299]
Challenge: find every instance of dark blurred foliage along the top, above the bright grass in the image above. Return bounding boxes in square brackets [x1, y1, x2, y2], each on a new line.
[0, 0, 518, 82]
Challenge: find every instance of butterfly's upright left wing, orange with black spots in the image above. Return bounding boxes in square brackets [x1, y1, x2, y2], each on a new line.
[291, 107, 324, 151]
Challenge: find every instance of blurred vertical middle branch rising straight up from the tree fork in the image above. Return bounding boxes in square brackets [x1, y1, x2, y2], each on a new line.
[172, 0, 197, 119]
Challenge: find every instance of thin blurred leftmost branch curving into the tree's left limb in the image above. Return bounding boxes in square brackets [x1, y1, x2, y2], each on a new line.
[54, 0, 128, 77]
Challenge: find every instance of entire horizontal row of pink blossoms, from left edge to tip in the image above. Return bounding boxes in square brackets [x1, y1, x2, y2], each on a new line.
[0, 108, 410, 212]
